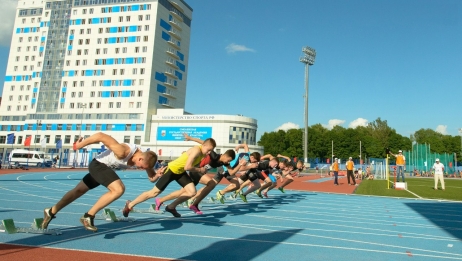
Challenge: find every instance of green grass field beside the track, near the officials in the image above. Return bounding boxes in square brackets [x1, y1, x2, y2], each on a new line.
[355, 178, 462, 201]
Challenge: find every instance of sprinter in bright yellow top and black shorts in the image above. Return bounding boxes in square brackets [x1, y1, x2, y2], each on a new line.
[122, 138, 217, 217]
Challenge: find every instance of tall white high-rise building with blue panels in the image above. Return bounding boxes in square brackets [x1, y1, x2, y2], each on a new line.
[0, 0, 192, 158]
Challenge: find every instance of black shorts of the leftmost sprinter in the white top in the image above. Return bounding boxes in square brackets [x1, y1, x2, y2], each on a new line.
[82, 159, 120, 189]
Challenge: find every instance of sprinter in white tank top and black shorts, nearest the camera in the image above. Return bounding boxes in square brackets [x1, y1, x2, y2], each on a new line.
[42, 132, 157, 232]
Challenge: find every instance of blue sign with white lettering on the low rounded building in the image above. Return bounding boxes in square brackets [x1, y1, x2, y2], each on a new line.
[157, 126, 212, 141]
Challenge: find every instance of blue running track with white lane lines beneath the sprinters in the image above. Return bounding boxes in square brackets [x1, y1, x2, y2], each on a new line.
[0, 171, 462, 261]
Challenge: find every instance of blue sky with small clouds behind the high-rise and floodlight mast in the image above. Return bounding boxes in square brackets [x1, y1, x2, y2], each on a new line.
[0, 0, 462, 140]
